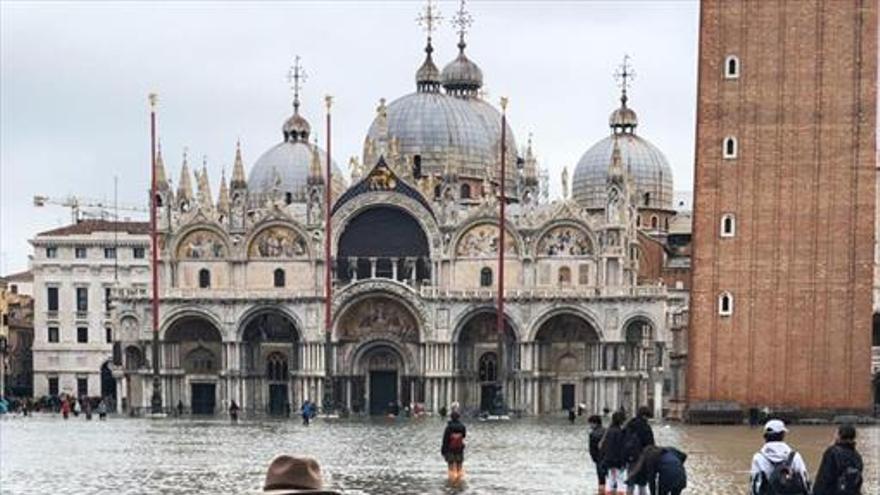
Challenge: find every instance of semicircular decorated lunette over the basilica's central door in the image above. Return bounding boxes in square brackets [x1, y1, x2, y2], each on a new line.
[339, 297, 418, 342]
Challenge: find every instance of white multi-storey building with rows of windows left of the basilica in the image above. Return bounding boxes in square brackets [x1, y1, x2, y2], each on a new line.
[30, 220, 150, 404]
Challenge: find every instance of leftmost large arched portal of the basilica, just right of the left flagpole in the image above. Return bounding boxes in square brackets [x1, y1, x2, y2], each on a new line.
[162, 316, 224, 415]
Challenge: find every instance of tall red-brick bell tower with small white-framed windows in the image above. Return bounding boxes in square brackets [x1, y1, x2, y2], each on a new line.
[687, 0, 878, 414]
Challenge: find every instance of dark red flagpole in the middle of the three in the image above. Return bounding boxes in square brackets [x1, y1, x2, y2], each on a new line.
[323, 95, 335, 412]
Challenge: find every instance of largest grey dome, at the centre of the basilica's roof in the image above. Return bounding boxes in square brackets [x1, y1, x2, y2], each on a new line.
[364, 92, 516, 191]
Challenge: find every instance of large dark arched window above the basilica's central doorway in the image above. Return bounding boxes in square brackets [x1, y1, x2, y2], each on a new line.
[337, 206, 431, 284]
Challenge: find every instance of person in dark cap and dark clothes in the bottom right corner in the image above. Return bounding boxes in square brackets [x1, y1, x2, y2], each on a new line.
[813, 424, 864, 495]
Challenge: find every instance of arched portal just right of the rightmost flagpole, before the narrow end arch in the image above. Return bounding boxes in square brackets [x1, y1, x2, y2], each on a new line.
[533, 313, 600, 412]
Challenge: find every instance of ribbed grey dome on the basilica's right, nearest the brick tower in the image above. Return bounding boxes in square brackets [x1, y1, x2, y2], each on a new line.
[572, 133, 673, 210]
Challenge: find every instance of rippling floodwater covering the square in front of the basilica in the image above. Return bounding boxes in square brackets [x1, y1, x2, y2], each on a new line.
[0, 415, 880, 495]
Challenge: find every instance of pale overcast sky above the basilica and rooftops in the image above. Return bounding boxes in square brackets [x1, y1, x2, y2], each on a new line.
[0, 0, 699, 273]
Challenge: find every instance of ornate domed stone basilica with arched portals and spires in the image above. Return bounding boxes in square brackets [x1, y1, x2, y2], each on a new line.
[114, 2, 689, 415]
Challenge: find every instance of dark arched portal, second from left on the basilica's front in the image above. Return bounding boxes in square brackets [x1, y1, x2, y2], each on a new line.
[239, 309, 302, 416]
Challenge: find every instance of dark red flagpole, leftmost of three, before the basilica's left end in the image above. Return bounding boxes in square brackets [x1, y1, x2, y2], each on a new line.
[149, 93, 162, 415]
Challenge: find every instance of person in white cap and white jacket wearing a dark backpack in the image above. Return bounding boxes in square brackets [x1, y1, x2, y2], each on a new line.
[750, 419, 810, 495]
